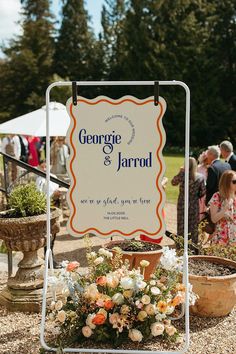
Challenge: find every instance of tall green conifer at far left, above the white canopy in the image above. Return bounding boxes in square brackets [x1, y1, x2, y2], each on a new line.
[0, 0, 54, 119]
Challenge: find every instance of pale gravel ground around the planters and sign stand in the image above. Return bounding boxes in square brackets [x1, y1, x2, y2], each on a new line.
[0, 205, 236, 354]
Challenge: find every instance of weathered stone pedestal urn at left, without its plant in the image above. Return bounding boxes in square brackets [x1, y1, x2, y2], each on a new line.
[0, 208, 61, 312]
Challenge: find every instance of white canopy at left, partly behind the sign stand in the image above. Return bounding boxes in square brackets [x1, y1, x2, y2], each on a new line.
[0, 102, 70, 136]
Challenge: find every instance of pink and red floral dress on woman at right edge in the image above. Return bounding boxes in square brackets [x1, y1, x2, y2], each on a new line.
[209, 192, 236, 245]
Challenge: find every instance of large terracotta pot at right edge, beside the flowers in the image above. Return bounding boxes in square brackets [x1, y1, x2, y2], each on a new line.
[189, 255, 236, 317]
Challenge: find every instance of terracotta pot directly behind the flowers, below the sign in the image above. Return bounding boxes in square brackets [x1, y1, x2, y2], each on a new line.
[105, 240, 162, 279]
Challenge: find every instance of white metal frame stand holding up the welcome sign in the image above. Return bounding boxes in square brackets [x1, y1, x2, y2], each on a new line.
[40, 81, 190, 354]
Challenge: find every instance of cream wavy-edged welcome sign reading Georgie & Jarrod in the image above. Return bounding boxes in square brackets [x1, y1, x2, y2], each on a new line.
[67, 96, 166, 239]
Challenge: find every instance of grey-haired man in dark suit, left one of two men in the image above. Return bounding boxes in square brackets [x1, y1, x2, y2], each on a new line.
[206, 145, 231, 205]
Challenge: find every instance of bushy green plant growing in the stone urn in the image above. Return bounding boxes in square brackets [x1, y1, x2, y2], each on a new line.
[9, 183, 46, 217]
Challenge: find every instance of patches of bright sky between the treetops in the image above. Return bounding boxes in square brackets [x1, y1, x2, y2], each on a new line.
[0, 0, 104, 56]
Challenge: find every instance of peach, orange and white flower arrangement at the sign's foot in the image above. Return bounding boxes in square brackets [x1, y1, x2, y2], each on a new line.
[48, 247, 194, 348]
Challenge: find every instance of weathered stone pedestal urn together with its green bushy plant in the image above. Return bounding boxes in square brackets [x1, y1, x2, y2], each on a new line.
[0, 183, 60, 311]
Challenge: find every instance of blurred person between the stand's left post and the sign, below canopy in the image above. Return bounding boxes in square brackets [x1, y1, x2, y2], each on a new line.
[50, 137, 69, 175]
